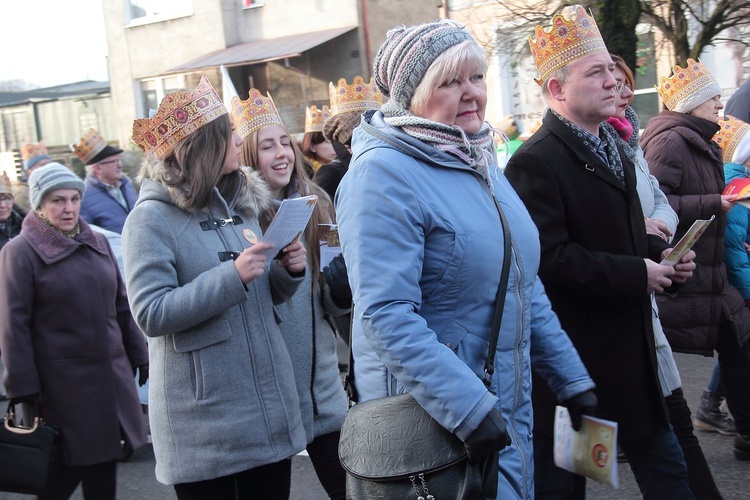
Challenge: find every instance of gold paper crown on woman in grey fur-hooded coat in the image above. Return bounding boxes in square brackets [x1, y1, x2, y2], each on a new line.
[133, 76, 227, 159]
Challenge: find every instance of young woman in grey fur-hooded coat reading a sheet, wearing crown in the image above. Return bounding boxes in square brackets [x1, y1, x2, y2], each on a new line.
[123, 78, 307, 500]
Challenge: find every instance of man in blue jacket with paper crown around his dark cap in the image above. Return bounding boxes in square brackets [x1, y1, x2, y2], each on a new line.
[72, 128, 138, 234]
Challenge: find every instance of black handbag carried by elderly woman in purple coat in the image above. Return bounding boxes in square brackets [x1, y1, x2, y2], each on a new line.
[0, 403, 61, 495]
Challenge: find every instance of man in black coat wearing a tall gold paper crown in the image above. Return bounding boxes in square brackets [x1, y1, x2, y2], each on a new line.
[505, 6, 695, 499]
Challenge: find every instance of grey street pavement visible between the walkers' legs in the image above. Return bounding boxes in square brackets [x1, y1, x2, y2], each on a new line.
[0, 354, 750, 500]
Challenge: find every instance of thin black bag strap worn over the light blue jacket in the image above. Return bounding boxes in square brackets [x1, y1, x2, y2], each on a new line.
[344, 194, 512, 408]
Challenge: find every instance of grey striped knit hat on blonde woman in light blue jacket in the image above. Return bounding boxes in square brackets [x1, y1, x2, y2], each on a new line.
[373, 19, 473, 109]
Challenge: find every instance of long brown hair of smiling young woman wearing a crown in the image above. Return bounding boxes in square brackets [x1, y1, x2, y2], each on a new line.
[242, 127, 336, 280]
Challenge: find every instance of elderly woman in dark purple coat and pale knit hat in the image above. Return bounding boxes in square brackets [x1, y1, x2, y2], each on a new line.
[0, 163, 148, 500]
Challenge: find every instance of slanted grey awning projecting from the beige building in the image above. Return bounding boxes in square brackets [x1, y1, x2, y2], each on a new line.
[167, 26, 357, 73]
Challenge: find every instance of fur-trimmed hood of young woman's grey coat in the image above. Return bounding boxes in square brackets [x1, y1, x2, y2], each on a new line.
[136, 154, 273, 217]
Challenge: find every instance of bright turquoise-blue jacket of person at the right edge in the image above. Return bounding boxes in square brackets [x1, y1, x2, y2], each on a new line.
[724, 163, 750, 300]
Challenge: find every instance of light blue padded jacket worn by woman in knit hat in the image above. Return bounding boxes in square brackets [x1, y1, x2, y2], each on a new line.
[336, 112, 594, 499]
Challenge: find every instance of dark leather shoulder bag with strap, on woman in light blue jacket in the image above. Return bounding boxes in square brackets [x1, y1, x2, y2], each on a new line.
[339, 196, 511, 500]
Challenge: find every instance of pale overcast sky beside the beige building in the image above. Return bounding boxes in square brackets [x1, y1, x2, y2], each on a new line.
[0, 0, 108, 87]
